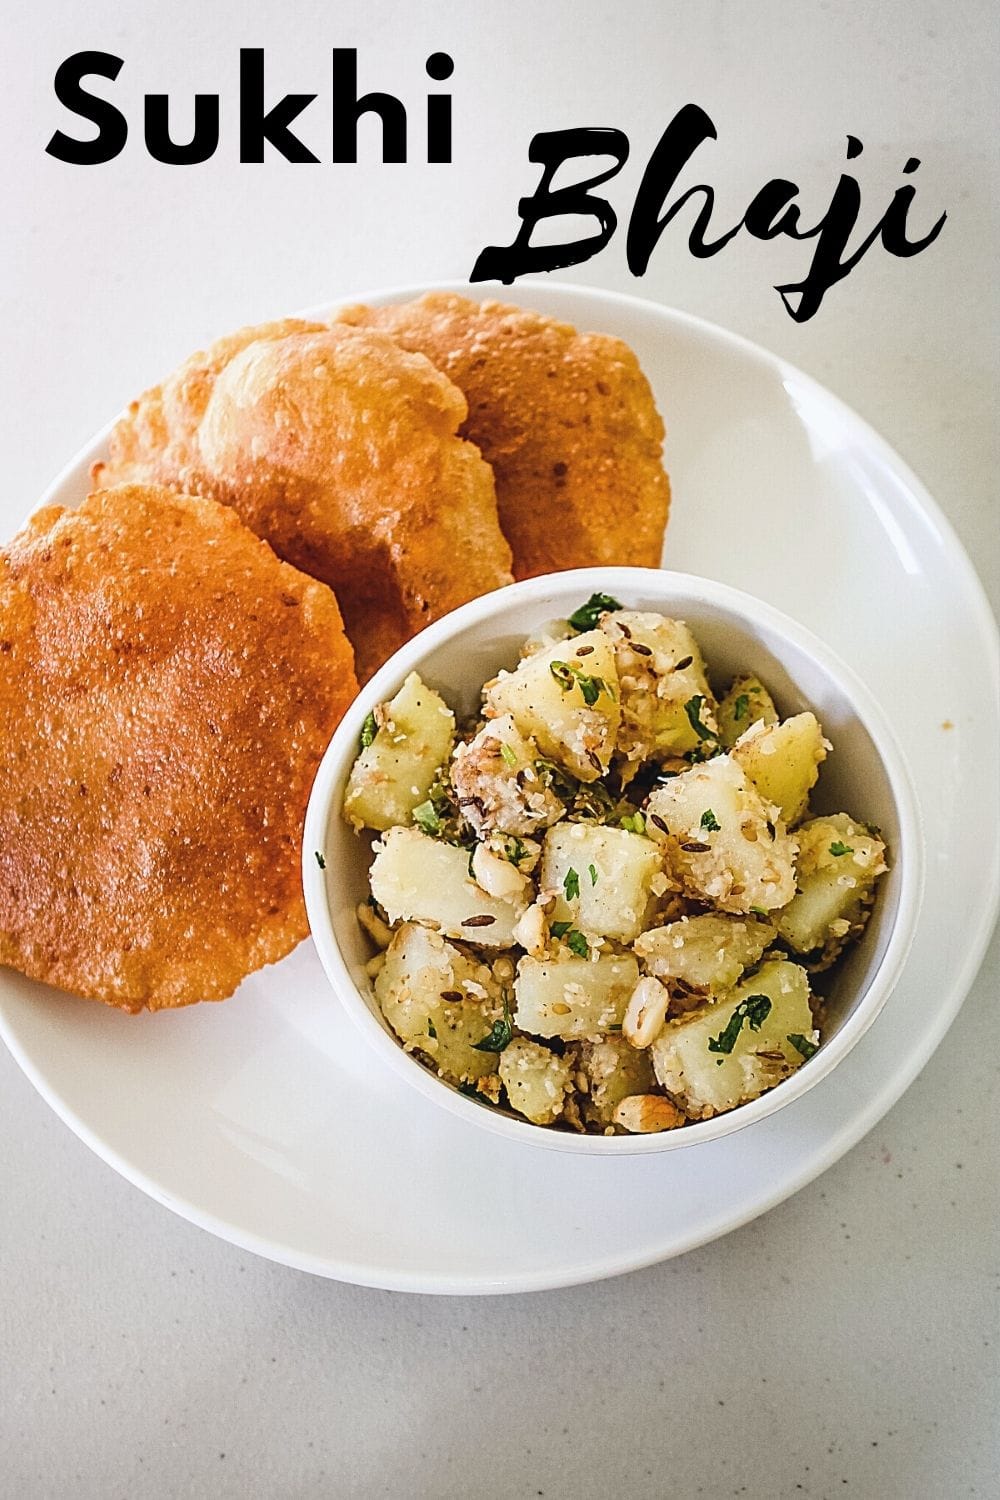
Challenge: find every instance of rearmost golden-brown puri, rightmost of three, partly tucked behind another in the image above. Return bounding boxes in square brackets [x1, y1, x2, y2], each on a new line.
[340, 293, 670, 578]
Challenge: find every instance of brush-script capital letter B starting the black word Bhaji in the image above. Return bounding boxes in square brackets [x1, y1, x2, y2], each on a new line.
[469, 126, 628, 285]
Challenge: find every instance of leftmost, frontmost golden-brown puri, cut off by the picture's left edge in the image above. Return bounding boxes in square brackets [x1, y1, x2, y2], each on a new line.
[0, 485, 357, 1011]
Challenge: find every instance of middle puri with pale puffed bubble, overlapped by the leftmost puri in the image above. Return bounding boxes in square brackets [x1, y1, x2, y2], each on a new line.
[96, 324, 511, 681]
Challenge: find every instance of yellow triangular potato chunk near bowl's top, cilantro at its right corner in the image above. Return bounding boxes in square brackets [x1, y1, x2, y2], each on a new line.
[484, 630, 621, 780]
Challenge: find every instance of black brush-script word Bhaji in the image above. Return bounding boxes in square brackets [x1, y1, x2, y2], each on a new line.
[469, 104, 948, 323]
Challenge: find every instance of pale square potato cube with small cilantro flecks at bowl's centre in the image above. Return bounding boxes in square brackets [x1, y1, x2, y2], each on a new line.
[541, 824, 663, 942]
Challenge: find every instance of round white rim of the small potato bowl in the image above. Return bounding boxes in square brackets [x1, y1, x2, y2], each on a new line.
[303, 567, 924, 1157]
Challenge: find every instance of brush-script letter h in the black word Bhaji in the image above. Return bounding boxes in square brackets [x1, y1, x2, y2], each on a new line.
[625, 104, 741, 276]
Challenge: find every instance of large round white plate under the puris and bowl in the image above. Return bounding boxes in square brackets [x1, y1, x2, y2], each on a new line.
[0, 285, 1000, 1293]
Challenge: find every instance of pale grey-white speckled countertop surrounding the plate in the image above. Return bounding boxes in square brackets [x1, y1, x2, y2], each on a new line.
[0, 0, 1000, 1500]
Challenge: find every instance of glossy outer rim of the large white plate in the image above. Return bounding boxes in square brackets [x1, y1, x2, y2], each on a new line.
[0, 279, 1000, 1296]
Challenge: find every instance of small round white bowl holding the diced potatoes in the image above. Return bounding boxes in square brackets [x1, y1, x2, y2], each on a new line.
[303, 567, 924, 1157]
